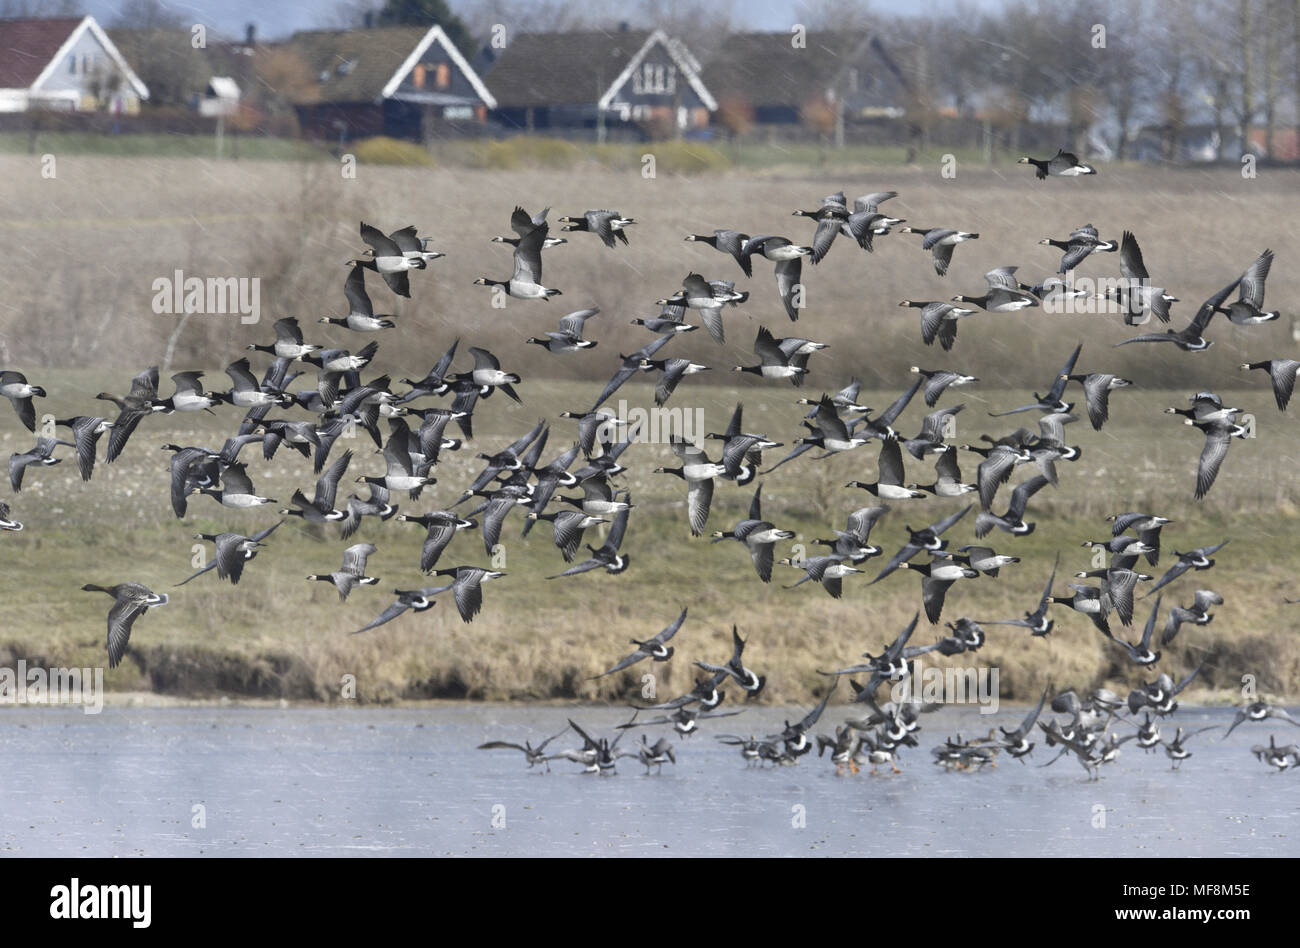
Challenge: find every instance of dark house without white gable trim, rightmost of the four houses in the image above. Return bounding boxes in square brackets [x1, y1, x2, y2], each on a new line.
[703, 31, 911, 126]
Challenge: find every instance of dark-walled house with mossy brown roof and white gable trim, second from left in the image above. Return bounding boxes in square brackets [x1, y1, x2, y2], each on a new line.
[280, 26, 497, 140]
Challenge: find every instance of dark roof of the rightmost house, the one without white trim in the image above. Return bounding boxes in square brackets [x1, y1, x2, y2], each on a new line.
[701, 31, 907, 109]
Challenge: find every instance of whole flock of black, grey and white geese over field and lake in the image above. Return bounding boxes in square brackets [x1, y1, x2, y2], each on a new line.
[0, 151, 1300, 776]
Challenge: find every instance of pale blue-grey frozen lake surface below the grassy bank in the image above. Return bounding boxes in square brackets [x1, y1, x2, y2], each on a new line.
[0, 705, 1300, 857]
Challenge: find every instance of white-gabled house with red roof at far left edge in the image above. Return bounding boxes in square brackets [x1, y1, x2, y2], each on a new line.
[0, 17, 150, 113]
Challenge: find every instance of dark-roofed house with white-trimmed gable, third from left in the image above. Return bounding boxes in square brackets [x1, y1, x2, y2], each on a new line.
[484, 29, 718, 135]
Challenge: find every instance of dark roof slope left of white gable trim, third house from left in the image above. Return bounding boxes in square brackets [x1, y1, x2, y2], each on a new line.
[484, 30, 650, 108]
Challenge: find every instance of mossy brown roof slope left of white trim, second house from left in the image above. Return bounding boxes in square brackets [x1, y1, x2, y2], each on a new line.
[283, 26, 429, 101]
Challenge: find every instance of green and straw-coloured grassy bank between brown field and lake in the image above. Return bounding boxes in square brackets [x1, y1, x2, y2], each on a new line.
[0, 377, 1300, 702]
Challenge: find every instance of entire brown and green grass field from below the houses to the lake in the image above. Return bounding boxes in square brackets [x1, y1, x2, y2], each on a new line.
[0, 156, 1300, 701]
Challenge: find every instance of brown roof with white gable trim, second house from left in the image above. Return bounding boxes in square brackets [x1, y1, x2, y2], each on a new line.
[283, 26, 497, 108]
